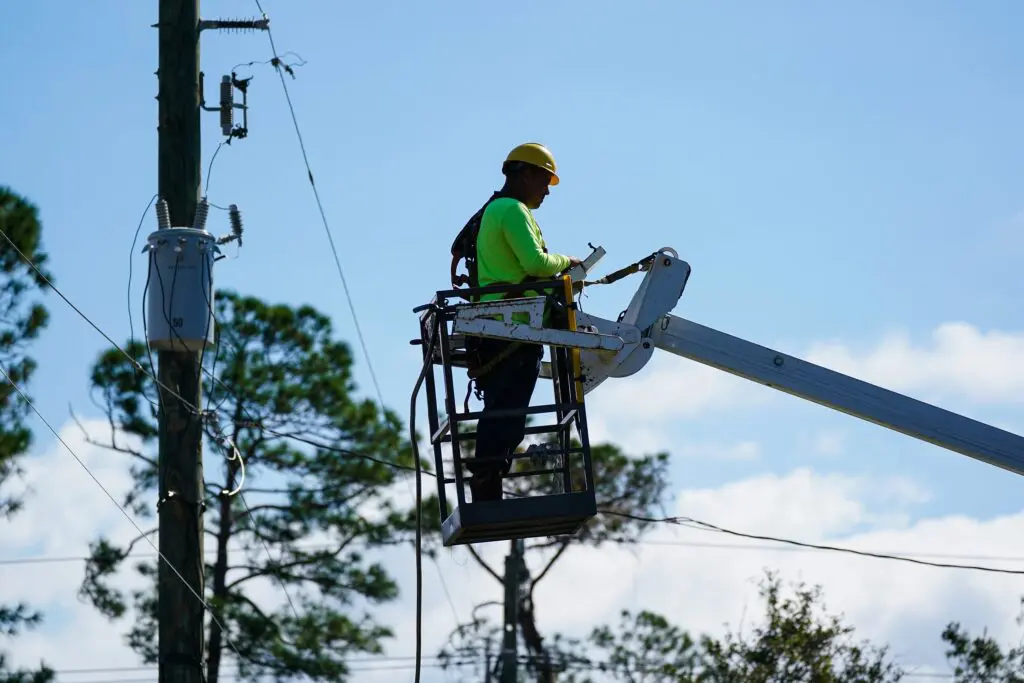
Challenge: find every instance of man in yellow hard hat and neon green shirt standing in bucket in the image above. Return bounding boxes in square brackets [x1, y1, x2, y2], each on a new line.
[452, 142, 580, 502]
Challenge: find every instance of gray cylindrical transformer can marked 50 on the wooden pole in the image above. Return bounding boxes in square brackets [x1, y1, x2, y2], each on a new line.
[142, 227, 220, 352]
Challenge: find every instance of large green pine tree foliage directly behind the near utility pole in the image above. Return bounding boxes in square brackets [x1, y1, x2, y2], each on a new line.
[75, 292, 439, 683]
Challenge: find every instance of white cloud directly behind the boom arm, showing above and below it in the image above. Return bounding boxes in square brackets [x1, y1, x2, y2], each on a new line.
[588, 323, 1024, 456]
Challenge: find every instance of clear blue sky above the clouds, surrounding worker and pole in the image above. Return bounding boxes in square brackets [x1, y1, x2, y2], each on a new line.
[0, 0, 1024, 679]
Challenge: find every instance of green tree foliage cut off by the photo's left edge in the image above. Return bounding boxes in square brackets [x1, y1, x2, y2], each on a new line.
[0, 186, 53, 683]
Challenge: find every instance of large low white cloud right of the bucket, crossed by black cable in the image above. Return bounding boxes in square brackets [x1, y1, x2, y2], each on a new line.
[495, 470, 1024, 675]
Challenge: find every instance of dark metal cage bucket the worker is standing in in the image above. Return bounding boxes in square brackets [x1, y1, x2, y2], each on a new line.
[411, 278, 597, 546]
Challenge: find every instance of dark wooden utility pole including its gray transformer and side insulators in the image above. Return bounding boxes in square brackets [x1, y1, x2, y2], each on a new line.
[146, 0, 270, 683]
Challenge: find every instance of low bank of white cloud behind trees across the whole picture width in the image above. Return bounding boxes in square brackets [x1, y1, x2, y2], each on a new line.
[6, 413, 1024, 682]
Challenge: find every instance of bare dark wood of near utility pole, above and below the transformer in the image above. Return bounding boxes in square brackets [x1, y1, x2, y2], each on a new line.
[157, 0, 206, 683]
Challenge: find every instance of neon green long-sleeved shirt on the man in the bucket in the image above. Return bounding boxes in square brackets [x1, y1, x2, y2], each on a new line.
[476, 197, 569, 305]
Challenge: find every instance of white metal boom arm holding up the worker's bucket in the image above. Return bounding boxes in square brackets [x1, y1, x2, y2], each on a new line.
[454, 249, 1024, 474]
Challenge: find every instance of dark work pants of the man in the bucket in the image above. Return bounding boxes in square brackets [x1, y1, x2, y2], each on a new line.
[466, 339, 544, 501]
